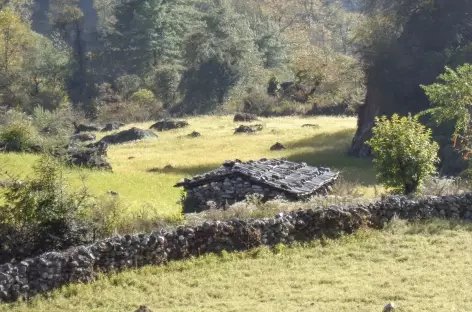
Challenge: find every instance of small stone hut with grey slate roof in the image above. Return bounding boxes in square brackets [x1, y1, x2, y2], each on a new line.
[175, 158, 339, 212]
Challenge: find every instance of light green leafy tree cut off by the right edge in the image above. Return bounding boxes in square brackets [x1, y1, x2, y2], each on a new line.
[421, 64, 472, 158]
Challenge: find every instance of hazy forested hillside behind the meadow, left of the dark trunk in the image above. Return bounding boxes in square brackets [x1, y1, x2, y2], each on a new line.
[0, 0, 364, 121]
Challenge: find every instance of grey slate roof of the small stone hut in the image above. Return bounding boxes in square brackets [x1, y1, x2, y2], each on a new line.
[174, 158, 339, 196]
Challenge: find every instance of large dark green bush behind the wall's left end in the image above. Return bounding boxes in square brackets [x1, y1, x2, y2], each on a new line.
[0, 155, 95, 262]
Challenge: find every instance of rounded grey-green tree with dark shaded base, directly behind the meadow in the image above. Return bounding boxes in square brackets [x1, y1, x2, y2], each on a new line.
[180, 3, 262, 113]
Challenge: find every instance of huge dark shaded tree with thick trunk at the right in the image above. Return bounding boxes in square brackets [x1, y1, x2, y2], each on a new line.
[350, 0, 472, 158]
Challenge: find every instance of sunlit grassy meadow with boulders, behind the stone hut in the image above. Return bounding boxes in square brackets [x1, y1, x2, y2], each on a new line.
[0, 116, 375, 217]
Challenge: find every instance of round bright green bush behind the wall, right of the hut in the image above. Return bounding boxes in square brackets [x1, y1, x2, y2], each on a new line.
[367, 114, 439, 194]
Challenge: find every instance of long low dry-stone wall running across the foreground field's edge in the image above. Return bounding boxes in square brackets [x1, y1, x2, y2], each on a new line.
[0, 194, 472, 302]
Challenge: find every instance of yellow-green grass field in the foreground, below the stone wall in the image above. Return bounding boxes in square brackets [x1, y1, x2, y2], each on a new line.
[5, 221, 472, 312]
